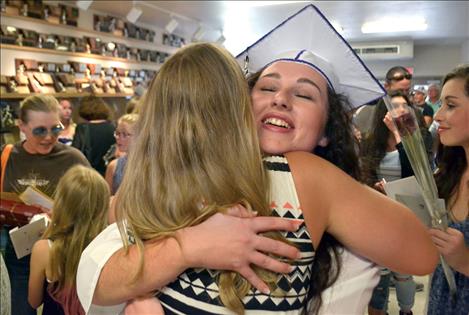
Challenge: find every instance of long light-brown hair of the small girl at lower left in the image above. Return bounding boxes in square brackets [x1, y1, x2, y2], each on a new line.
[43, 165, 110, 314]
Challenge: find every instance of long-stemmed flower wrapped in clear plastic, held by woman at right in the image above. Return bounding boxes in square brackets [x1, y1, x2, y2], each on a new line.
[384, 95, 456, 296]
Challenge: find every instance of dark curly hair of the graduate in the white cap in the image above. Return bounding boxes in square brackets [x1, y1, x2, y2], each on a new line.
[248, 68, 361, 313]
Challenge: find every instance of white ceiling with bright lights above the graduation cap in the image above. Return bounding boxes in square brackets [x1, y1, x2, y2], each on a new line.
[86, 0, 469, 54]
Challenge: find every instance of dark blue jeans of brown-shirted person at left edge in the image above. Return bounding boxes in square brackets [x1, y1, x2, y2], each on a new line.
[2, 231, 36, 315]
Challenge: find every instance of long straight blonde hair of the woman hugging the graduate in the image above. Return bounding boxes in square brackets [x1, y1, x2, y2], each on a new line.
[116, 43, 276, 313]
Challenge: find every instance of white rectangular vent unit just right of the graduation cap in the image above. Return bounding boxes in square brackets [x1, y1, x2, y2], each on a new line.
[352, 41, 414, 60]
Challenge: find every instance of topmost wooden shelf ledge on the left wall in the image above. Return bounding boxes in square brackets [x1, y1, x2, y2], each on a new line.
[0, 13, 178, 54]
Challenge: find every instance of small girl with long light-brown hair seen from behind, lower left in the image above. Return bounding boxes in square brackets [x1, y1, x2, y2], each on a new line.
[28, 166, 110, 315]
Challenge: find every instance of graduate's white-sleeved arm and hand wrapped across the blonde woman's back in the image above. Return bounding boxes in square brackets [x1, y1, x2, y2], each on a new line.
[77, 209, 301, 311]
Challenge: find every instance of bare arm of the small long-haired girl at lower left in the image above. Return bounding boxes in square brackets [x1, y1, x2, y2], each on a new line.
[28, 240, 49, 308]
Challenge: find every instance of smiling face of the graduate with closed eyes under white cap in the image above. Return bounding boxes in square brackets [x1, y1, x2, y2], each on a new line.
[251, 61, 328, 154]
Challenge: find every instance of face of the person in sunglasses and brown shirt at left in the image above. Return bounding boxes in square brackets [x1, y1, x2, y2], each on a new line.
[20, 111, 60, 155]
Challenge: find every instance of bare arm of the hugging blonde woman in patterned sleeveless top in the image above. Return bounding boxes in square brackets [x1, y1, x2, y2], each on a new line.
[287, 152, 438, 275]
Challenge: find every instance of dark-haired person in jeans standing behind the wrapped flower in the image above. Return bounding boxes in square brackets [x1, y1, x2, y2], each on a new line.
[361, 91, 425, 315]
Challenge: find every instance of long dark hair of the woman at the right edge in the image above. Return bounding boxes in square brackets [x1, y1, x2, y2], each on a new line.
[435, 64, 469, 209]
